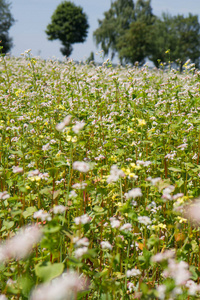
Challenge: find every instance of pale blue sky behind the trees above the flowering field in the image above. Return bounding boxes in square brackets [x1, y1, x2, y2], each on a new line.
[10, 0, 200, 61]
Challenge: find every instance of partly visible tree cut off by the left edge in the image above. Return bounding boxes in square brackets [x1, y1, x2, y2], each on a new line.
[0, 0, 14, 53]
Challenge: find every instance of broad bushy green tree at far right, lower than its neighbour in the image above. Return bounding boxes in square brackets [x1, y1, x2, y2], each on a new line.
[149, 14, 200, 70]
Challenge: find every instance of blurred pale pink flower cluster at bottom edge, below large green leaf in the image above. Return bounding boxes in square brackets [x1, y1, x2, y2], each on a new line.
[30, 272, 84, 300]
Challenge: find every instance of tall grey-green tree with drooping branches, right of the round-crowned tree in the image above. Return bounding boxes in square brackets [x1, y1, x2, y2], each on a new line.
[94, 0, 155, 64]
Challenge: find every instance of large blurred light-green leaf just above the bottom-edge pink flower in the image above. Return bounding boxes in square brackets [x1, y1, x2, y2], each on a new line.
[35, 262, 64, 282]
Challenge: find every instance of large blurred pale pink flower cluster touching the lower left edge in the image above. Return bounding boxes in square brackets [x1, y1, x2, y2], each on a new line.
[0, 225, 42, 262]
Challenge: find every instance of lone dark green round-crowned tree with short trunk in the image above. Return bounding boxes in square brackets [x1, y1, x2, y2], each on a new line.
[46, 1, 89, 56]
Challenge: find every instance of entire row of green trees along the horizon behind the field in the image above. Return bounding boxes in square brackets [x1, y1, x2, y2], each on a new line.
[0, 0, 200, 69]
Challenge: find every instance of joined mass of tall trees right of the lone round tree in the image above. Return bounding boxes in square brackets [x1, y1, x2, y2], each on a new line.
[94, 0, 200, 70]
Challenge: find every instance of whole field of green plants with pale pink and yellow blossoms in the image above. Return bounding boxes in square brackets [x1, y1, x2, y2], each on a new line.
[0, 51, 200, 300]
